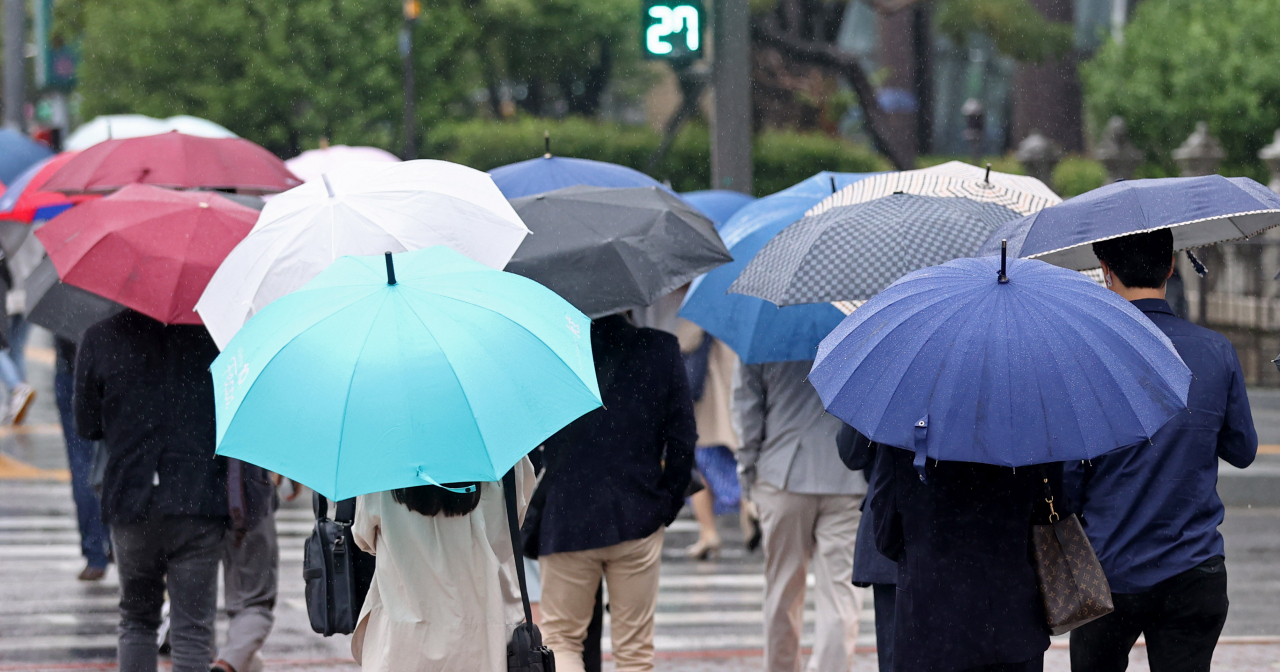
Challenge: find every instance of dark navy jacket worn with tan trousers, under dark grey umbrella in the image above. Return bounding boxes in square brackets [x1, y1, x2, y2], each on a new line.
[539, 316, 698, 556]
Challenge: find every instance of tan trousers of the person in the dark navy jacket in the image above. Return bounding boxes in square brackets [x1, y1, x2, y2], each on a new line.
[539, 530, 663, 672]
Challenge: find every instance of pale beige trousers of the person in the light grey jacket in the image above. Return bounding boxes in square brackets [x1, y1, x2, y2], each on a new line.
[751, 483, 863, 672]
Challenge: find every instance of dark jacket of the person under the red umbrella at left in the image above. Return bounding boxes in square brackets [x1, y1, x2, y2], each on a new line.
[74, 310, 227, 525]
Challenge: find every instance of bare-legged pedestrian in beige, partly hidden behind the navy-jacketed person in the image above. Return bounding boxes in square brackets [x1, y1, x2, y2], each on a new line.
[676, 317, 742, 559]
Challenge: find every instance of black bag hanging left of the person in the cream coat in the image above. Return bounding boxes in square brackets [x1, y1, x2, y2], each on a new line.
[302, 493, 374, 637]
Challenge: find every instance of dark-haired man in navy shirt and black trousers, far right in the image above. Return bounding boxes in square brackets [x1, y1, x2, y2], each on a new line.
[1064, 229, 1258, 672]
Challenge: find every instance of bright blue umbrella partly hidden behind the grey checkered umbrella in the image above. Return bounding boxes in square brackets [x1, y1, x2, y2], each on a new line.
[680, 173, 870, 364]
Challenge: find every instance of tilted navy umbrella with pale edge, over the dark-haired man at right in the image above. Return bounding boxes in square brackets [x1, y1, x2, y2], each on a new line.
[982, 175, 1280, 270]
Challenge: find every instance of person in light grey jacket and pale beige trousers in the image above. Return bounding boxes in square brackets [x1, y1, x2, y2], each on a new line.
[733, 361, 867, 672]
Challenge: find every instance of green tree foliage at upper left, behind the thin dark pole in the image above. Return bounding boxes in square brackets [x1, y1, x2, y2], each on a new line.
[59, 0, 475, 156]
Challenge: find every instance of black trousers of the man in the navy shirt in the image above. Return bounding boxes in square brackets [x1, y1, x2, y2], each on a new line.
[1071, 556, 1228, 672]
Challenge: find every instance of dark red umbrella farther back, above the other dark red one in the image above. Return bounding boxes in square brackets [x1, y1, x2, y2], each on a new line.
[44, 131, 302, 193]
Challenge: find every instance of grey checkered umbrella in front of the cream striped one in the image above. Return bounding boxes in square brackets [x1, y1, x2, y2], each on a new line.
[728, 193, 1020, 306]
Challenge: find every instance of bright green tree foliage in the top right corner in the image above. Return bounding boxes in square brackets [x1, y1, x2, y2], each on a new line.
[1082, 0, 1280, 172]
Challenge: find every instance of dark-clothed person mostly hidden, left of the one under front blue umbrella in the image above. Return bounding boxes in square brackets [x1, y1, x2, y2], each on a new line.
[836, 425, 897, 672]
